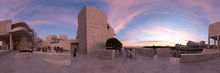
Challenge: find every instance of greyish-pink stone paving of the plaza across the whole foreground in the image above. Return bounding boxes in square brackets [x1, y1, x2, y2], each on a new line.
[0, 52, 220, 73]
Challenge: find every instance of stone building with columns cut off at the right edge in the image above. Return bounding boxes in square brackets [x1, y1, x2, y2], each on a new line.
[208, 22, 220, 50]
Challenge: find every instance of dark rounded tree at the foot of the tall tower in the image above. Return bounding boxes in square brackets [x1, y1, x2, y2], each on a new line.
[105, 38, 122, 50]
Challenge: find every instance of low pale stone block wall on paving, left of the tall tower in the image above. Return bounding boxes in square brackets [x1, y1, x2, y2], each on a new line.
[43, 53, 72, 66]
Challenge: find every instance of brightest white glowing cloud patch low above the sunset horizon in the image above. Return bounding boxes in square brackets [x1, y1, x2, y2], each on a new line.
[143, 26, 201, 44]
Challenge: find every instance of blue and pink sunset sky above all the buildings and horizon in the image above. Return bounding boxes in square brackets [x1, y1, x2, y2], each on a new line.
[0, 0, 220, 46]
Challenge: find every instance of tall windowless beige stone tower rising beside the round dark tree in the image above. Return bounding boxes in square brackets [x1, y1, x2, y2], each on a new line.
[77, 6, 114, 54]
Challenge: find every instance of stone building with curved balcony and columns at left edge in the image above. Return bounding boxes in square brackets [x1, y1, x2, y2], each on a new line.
[0, 20, 34, 50]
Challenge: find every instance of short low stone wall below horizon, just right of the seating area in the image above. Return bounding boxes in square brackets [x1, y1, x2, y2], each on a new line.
[136, 48, 155, 57]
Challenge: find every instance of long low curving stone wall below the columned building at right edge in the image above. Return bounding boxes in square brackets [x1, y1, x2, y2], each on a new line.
[180, 50, 220, 63]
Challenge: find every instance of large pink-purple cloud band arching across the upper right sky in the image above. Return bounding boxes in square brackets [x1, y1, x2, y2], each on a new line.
[100, 0, 220, 33]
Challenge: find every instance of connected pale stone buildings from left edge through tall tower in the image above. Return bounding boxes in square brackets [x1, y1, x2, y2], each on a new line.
[0, 6, 114, 54]
